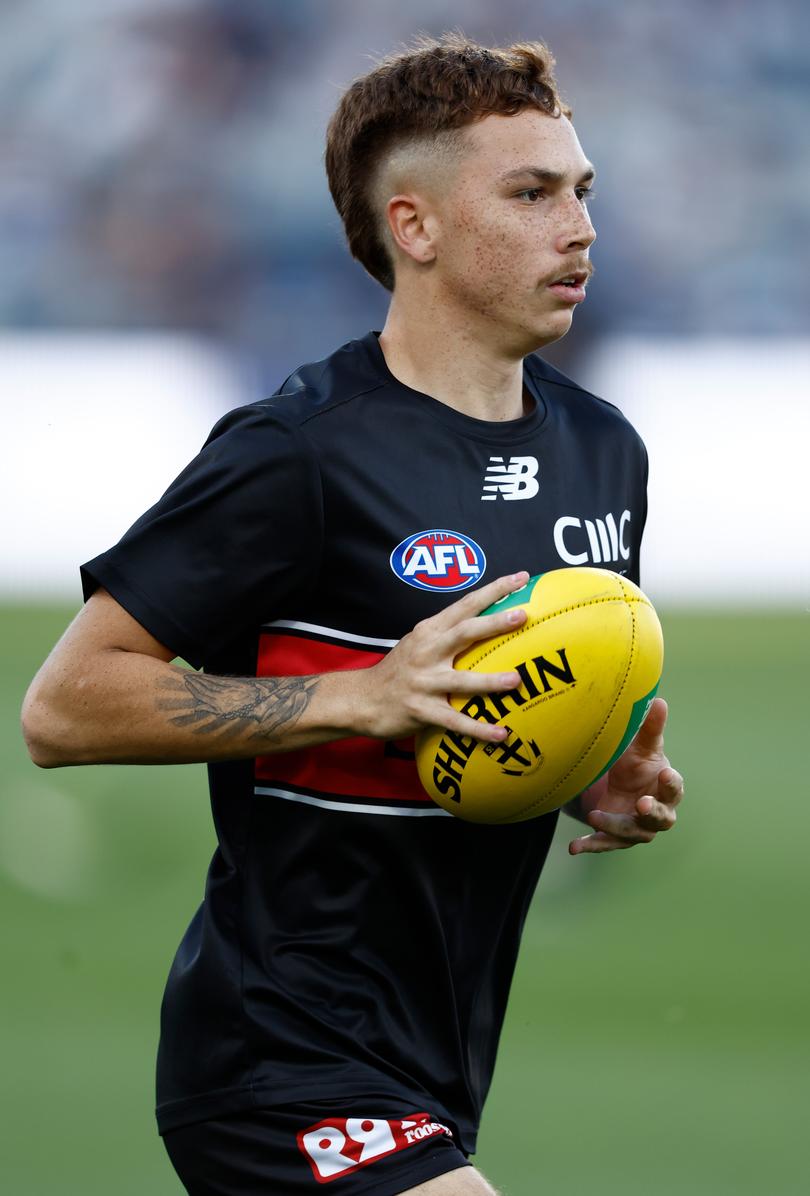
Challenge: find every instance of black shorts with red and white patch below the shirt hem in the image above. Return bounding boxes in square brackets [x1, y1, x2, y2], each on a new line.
[164, 1097, 470, 1196]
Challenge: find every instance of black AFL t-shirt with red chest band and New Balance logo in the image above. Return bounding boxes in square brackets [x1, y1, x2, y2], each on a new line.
[83, 332, 647, 1151]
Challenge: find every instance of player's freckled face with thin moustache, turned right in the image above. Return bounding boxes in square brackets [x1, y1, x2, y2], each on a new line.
[436, 109, 596, 355]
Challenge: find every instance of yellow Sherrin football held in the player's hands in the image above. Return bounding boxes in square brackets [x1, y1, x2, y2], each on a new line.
[416, 566, 664, 823]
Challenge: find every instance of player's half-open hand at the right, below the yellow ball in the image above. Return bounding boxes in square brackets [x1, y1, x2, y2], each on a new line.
[565, 697, 683, 855]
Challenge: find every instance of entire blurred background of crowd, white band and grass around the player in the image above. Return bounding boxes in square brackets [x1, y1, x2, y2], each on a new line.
[0, 0, 810, 1196]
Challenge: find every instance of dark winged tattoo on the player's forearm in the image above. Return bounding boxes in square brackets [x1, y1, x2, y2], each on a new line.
[157, 669, 321, 739]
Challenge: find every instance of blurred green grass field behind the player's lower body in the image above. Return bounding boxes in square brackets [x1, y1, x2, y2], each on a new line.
[0, 606, 810, 1196]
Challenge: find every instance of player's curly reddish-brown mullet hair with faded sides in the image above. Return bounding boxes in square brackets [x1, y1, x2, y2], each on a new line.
[325, 32, 571, 291]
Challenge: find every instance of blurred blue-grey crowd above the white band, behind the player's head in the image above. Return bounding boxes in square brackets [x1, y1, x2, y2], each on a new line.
[0, 0, 810, 388]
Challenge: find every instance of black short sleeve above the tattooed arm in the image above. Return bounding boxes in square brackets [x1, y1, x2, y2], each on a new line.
[81, 403, 323, 669]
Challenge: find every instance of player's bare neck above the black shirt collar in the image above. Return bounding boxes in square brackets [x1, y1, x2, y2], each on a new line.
[379, 287, 529, 421]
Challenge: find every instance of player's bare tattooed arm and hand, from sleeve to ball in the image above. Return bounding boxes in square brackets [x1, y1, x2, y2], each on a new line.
[23, 573, 528, 768]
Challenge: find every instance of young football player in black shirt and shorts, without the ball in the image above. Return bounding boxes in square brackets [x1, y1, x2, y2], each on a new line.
[24, 36, 682, 1196]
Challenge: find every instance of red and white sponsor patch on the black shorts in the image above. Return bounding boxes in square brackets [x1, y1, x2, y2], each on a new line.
[298, 1113, 452, 1184]
